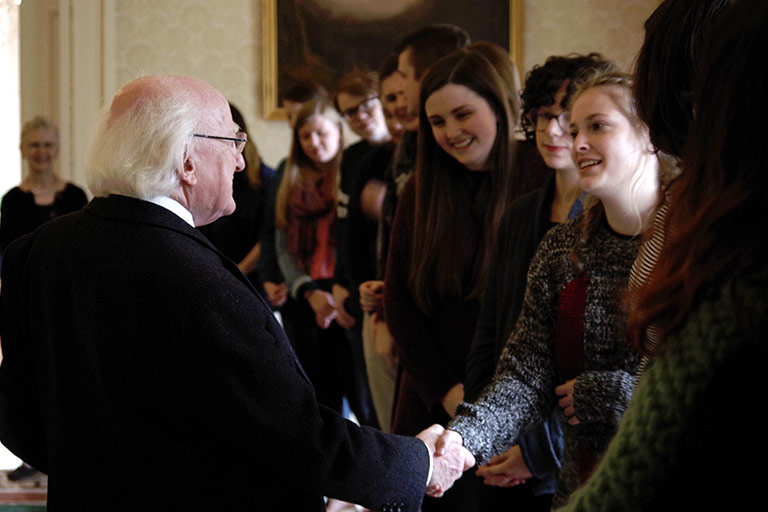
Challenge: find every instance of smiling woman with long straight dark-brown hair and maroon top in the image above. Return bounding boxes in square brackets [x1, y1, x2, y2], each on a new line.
[384, 50, 518, 510]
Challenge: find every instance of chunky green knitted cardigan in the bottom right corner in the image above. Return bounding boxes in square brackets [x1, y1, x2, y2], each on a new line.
[564, 270, 768, 511]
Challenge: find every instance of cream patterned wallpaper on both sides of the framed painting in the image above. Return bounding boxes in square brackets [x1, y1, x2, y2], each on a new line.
[115, 0, 659, 166]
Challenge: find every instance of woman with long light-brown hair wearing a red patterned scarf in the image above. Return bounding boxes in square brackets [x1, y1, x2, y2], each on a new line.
[275, 99, 354, 418]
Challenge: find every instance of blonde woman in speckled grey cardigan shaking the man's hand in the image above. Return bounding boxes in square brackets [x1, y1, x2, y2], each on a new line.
[446, 69, 680, 506]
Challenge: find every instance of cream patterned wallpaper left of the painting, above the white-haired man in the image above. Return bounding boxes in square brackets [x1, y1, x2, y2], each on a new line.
[115, 0, 290, 166]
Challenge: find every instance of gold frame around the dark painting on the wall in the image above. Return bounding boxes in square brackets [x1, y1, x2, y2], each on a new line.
[261, 0, 523, 120]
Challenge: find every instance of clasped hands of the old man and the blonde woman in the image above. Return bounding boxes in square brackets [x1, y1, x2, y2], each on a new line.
[416, 425, 475, 498]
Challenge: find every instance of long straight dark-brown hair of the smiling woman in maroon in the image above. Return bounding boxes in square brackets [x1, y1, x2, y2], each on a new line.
[408, 49, 517, 313]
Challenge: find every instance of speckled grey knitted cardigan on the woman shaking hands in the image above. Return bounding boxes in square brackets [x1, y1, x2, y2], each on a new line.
[448, 217, 640, 506]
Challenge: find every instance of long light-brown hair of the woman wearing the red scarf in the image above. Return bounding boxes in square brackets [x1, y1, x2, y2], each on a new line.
[275, 98, 344, 229]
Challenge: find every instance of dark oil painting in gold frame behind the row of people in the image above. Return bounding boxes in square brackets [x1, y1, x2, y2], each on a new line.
[261, 0, 523, 119]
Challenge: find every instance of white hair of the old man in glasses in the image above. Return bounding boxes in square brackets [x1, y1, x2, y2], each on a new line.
[86, 77, 203, 199]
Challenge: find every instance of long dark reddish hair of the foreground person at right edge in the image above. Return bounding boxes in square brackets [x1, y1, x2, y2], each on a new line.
[629, 0, 768, 348]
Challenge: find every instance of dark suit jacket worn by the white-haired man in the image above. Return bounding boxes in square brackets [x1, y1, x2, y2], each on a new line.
[0, 196, 429, 511]
